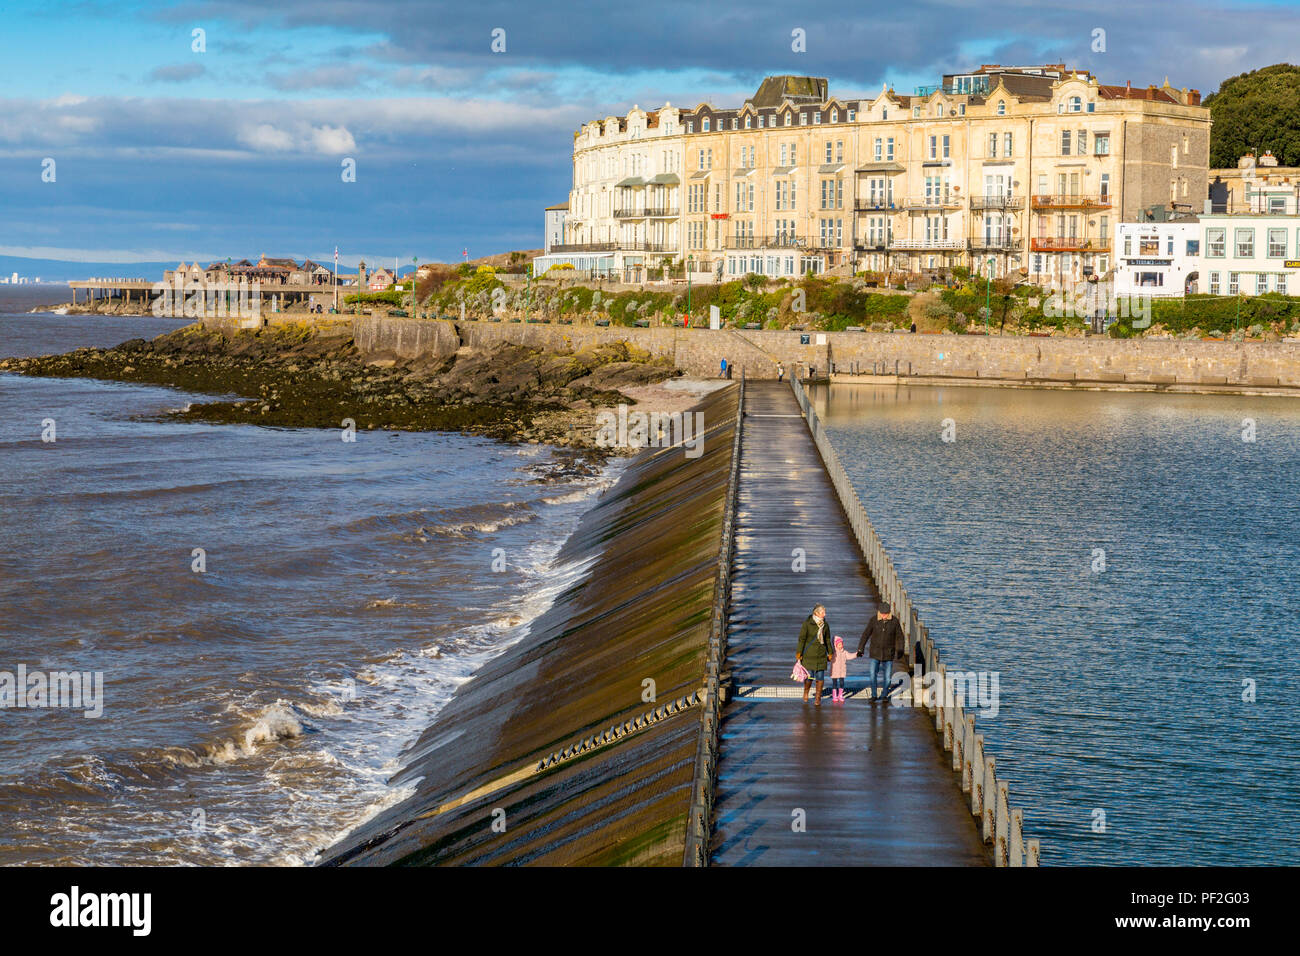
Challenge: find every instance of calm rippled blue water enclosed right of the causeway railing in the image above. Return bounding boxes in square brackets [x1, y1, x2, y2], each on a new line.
[816, 386, 1300, 865]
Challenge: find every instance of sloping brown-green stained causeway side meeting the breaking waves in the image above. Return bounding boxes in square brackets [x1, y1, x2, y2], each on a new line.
[322, 382, 738, 866]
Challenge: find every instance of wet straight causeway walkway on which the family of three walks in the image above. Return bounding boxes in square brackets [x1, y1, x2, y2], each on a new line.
[710, 381, 992, 866]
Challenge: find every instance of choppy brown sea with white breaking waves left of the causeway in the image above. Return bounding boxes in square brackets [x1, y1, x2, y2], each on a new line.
[0, 306, 610, 864]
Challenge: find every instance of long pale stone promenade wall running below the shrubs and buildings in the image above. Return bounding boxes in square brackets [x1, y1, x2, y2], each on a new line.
[332, 316, 1300, 389]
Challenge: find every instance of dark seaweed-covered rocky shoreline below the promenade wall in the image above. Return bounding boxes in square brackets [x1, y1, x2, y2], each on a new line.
[0, 323, 680, 463]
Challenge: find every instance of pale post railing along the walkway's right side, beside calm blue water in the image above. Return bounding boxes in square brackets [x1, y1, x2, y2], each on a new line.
[785, 377, 1040, 866]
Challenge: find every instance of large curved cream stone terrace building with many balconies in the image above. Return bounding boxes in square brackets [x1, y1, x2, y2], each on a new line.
[537, 64, 1210, 284]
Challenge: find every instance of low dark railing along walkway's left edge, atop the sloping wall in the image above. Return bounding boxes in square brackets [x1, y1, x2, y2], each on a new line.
[683, 369, 745, 866]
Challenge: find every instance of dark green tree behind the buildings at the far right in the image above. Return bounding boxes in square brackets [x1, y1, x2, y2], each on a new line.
[1204, 64, 1300, 169]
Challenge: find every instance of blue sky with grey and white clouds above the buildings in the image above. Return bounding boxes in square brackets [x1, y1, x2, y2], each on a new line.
[0, 0, 1300, 267]
